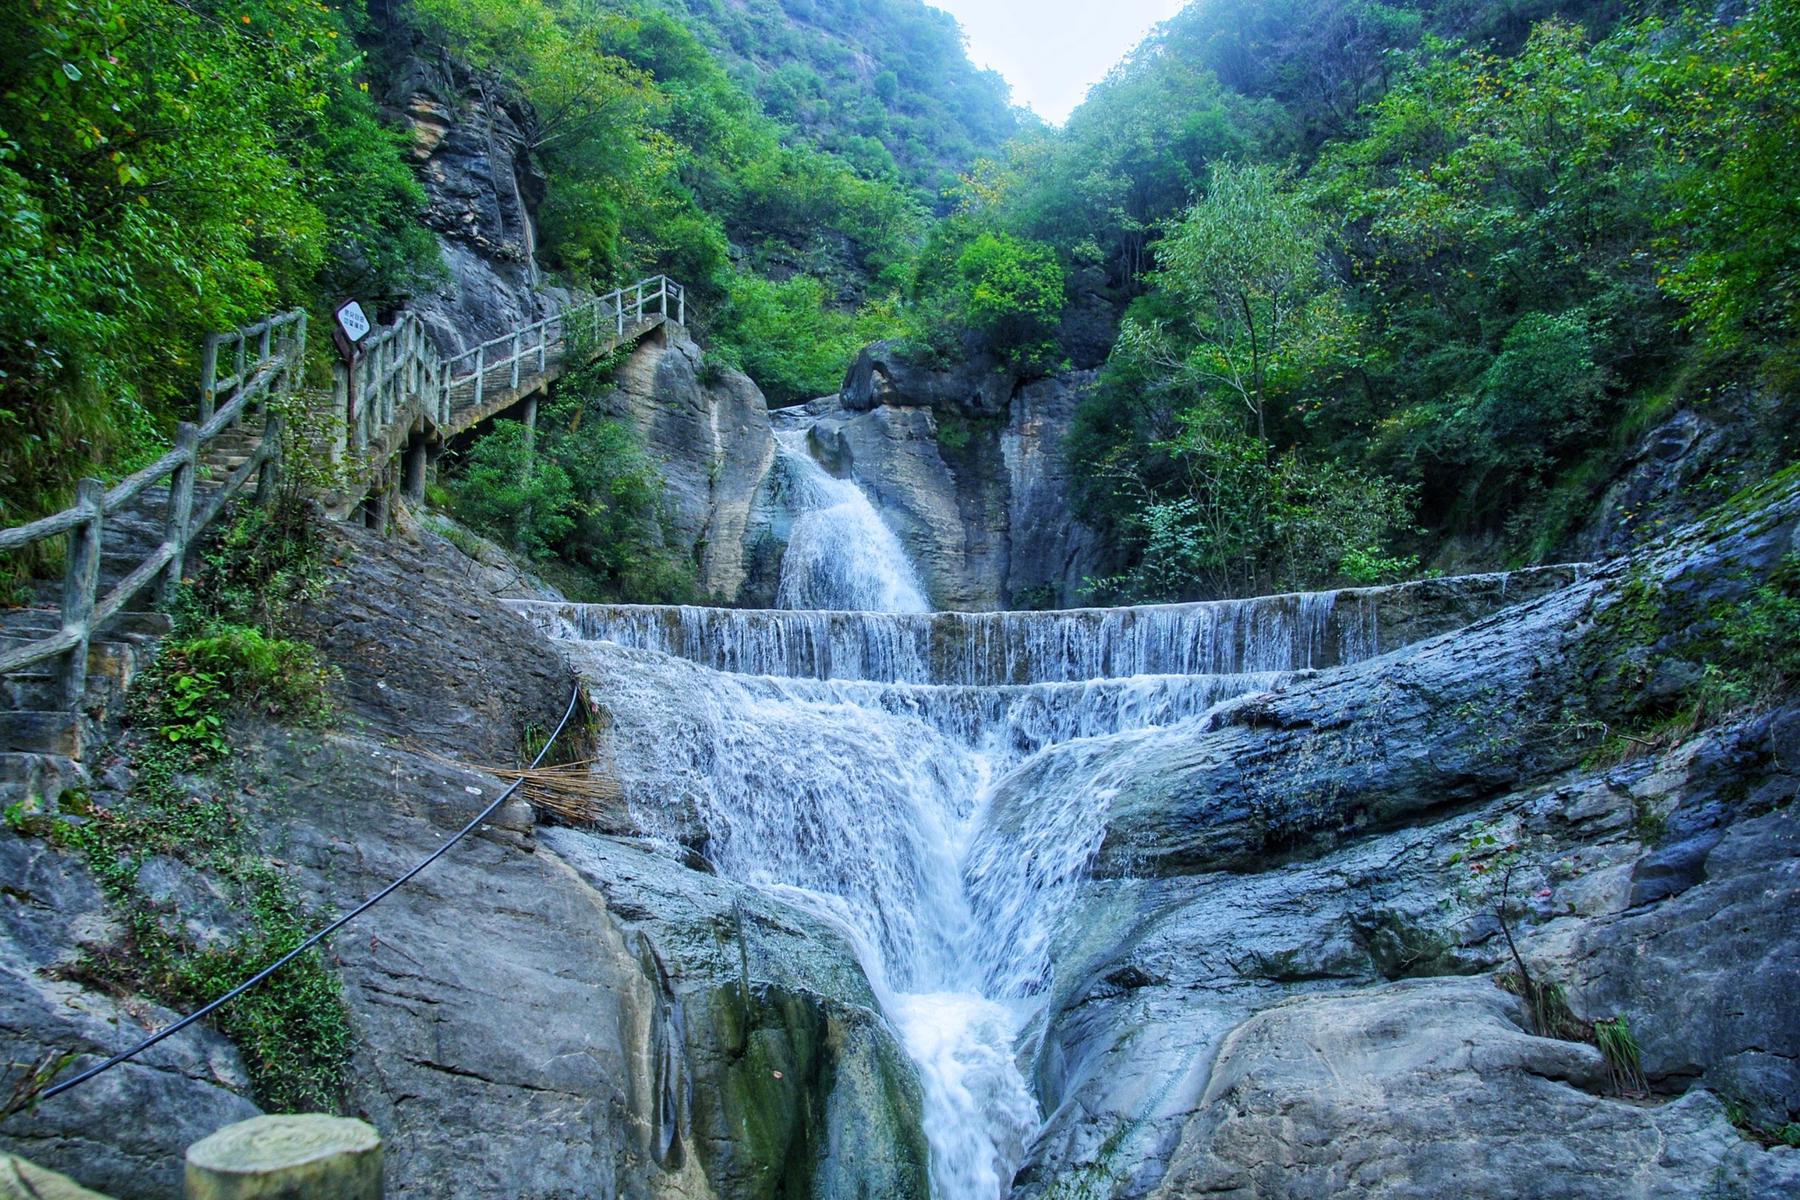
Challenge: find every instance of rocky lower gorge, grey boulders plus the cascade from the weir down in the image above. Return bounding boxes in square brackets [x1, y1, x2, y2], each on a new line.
[0, 444, 1800, 1196]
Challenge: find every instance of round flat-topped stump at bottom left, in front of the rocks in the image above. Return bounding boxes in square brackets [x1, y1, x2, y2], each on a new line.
[187, 1114, 382, 1200]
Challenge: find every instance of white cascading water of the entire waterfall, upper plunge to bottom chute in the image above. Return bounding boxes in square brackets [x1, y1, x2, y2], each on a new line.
[518, 434, 1377, 1200]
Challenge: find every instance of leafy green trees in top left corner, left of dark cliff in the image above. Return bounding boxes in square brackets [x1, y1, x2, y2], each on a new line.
[0, 0, 436, 522]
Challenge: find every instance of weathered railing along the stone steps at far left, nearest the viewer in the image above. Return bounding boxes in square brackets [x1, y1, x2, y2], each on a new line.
[0, 311, 306, 709]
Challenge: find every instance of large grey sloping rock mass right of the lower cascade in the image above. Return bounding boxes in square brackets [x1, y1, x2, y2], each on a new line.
[995, 488, 1800, 1198]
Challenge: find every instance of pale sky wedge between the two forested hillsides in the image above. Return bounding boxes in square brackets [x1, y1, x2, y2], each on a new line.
[927, 0, 1184, 124]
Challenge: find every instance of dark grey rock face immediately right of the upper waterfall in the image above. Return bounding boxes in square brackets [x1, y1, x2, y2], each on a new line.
[808, 342, 1109, 610]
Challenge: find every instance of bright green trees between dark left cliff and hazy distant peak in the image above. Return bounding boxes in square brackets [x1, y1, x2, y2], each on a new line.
[409, 0, 925, 403]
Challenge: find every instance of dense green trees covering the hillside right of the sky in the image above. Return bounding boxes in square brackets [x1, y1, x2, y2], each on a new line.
[902, 0, 1800, 597]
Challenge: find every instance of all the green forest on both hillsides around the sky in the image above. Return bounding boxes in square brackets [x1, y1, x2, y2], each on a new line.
[0, 0, 1800, 597]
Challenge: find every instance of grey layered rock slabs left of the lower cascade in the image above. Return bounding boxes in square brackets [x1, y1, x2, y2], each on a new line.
[0, 529, 927, 1200]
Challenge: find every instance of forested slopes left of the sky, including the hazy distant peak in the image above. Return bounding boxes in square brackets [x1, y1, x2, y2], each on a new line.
[0, 0, 1013, 543]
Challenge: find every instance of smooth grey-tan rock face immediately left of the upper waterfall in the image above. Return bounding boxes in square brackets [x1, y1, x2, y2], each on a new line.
[608, 326, 776, 604]
